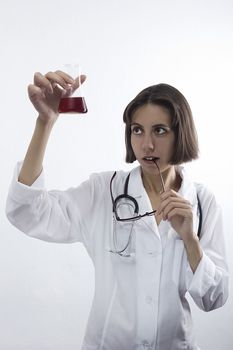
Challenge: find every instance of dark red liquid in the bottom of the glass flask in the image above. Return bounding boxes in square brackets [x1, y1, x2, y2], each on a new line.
[58, 97, 87, 113]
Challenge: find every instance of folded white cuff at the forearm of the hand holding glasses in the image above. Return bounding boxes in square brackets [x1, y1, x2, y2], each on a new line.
[186, 252, 216, 297]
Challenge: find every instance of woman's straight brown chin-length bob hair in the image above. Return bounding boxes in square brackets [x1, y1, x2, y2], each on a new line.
[123, 84, 199, 165]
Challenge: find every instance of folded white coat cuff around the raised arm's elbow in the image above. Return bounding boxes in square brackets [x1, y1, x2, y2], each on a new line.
[9, 162, 45, 204]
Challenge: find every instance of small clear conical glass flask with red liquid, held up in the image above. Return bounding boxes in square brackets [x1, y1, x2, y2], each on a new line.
[58, 64, 87, 114]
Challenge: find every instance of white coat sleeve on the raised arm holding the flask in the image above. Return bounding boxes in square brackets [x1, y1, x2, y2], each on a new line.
[6, 163, 106, 248]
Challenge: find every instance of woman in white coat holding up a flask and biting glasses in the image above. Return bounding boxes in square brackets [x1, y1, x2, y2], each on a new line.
[6, 71, 228, 350]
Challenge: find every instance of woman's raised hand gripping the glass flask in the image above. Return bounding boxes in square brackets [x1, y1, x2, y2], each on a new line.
[28, 70, 86, 122]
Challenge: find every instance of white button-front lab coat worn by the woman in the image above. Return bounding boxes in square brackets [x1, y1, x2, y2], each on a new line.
[6, 164, 228, 350]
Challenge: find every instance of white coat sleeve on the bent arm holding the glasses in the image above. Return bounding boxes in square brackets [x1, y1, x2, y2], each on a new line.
[186, 186, 229, 311]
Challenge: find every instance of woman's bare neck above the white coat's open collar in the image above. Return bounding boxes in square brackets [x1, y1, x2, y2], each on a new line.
[142, 166, 181, 194]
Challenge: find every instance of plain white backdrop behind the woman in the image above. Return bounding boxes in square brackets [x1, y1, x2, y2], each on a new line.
[0, 0, 233, 350]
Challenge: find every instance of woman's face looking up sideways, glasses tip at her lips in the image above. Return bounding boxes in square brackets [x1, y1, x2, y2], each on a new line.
[131, 104, 175, 174]
